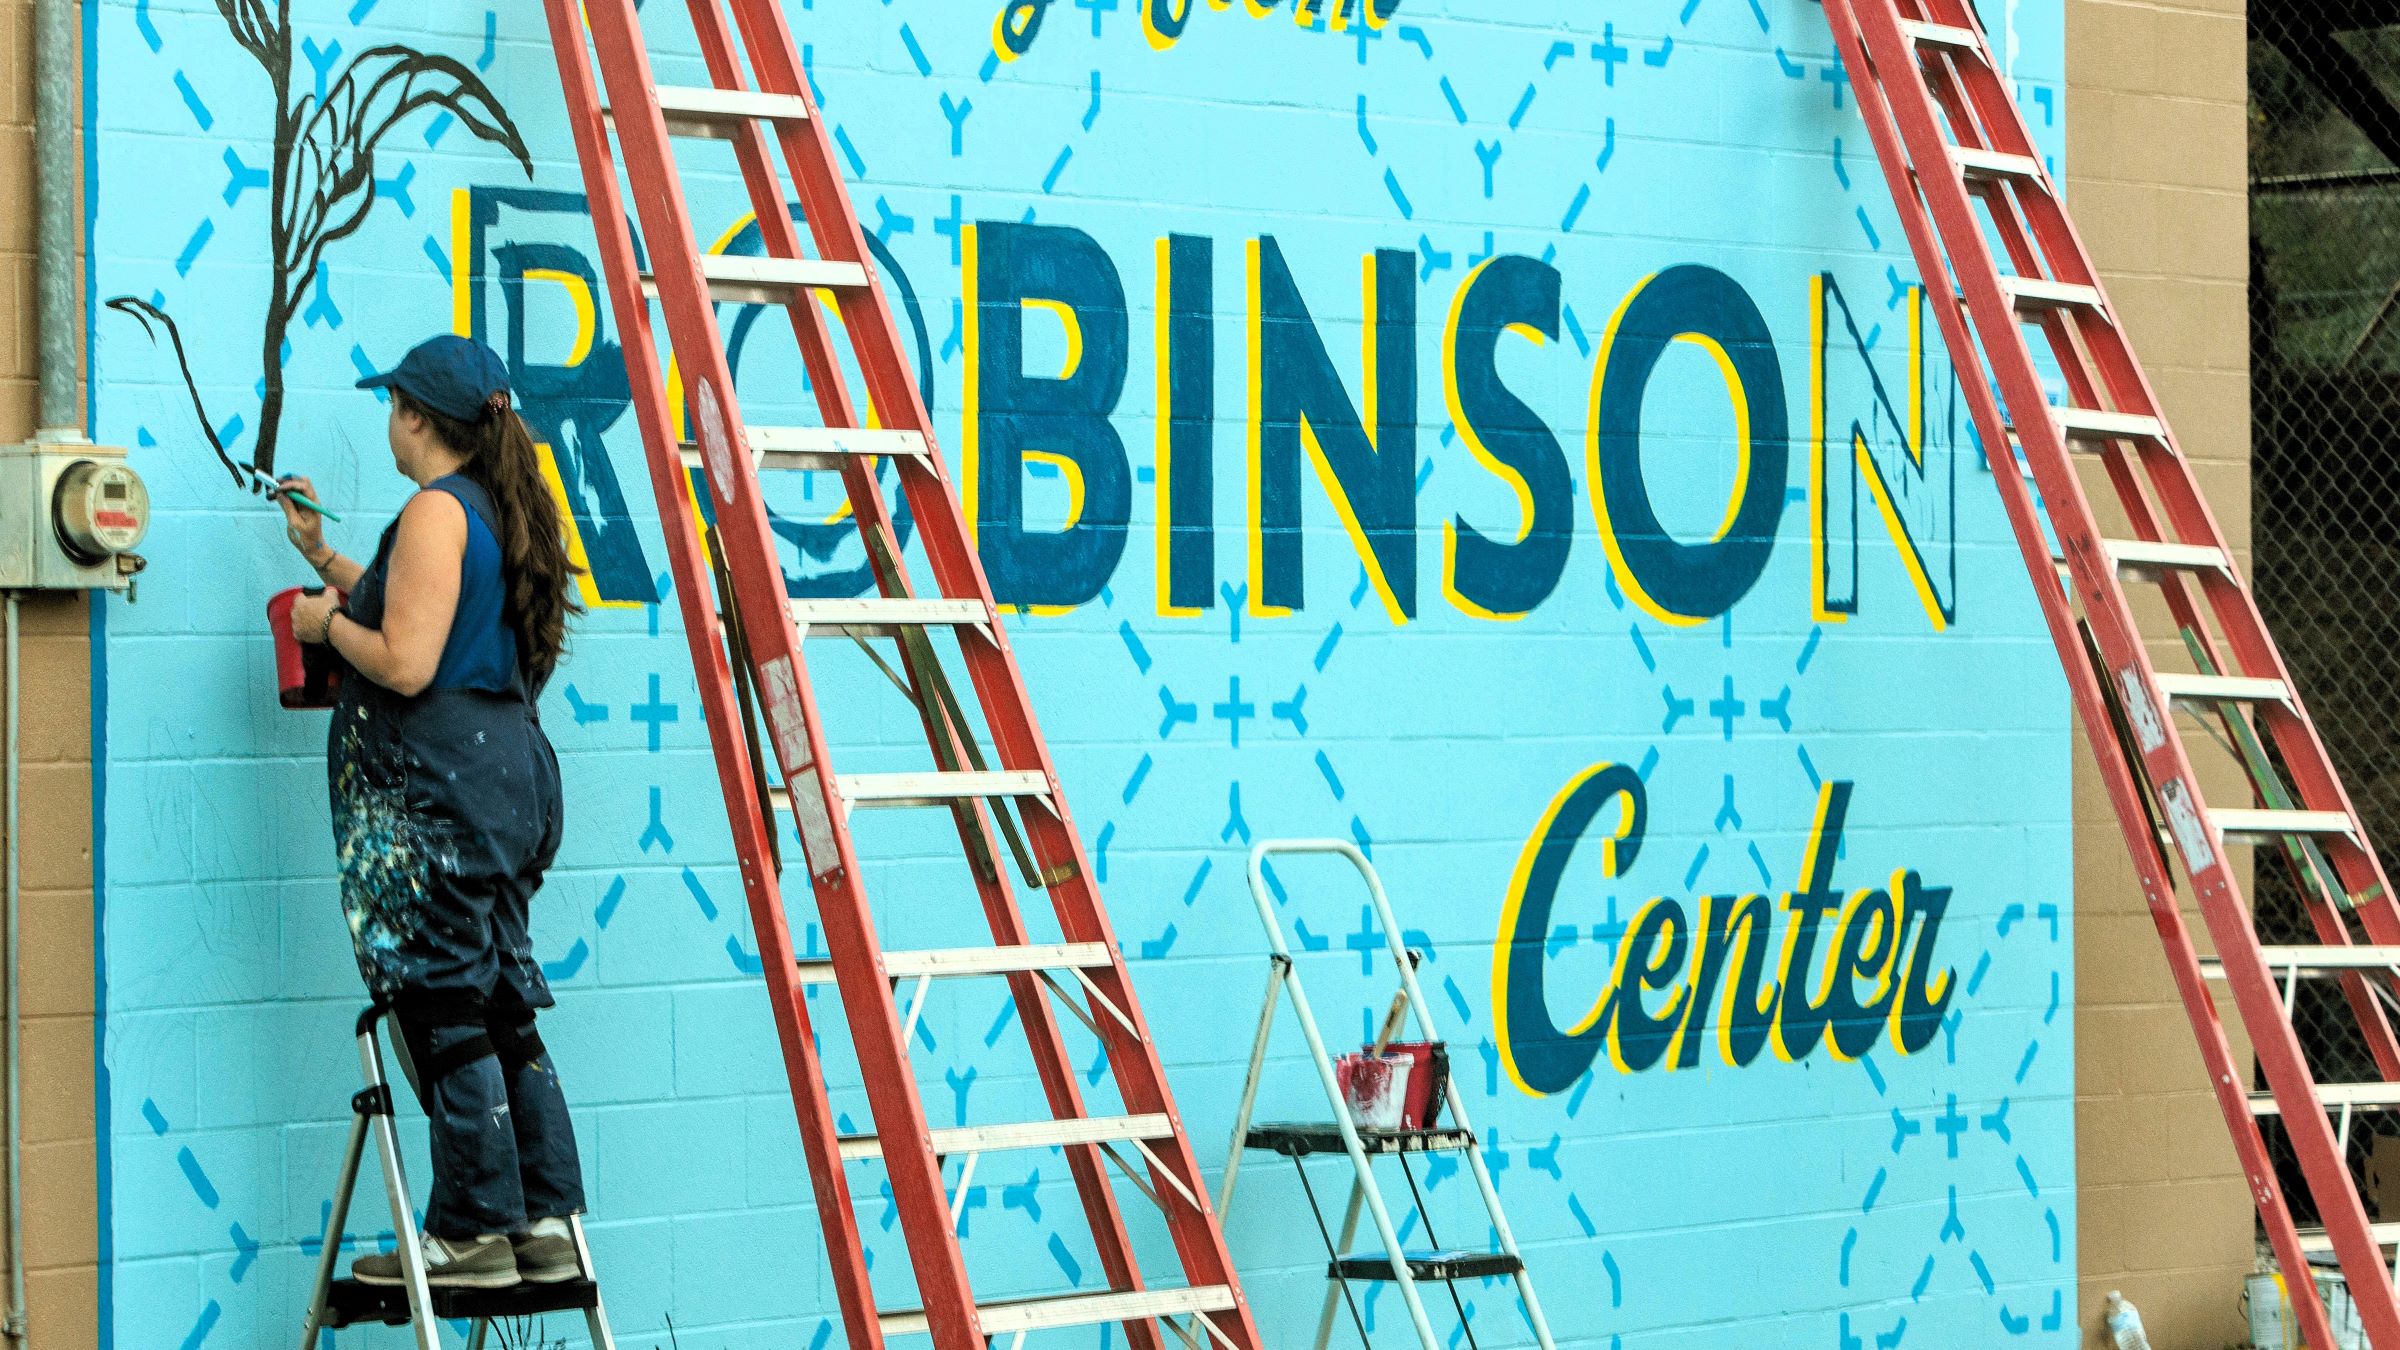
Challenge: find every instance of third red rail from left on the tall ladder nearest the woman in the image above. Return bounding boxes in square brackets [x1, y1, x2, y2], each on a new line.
[689, 0, 1162, 1350]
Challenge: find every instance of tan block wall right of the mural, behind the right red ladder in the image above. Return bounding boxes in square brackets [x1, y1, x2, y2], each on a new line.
[2066, 0, 2254, 1350]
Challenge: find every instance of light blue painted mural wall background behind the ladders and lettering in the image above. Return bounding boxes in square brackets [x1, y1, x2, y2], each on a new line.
[96, 0, 2076, 1350]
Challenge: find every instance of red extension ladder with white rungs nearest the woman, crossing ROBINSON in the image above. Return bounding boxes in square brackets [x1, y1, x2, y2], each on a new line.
[545, 0, 1260, 1350]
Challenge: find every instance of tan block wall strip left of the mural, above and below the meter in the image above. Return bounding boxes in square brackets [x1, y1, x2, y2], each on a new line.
[0, 0, 98, 1350]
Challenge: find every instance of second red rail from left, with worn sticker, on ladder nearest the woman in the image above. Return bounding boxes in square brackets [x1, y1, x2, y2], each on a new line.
[566, 0, 984, 1350]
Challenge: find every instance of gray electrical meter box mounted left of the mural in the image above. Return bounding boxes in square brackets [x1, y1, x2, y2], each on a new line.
[0, 440, 149, 591]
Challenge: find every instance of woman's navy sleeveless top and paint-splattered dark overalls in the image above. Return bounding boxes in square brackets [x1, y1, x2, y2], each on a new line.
[326, 476, 583, 1240]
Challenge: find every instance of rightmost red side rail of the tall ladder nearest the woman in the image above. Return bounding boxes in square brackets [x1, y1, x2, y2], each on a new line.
[732, 0, 1258, 1325]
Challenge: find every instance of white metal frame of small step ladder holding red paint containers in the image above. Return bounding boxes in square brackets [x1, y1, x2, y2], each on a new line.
[1217, 838, 1553, 1350]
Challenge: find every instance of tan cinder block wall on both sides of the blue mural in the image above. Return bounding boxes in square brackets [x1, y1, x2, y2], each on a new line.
[0, 0, 2251, 1348]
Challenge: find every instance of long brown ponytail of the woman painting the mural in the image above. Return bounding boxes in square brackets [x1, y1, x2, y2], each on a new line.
[391, 389, 583, 692]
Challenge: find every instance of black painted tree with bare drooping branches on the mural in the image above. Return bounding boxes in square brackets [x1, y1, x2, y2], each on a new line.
[108, 0, 533, 490]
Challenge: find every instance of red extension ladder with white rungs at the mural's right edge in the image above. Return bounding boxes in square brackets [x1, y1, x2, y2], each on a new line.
[1824, 0, 2400, 1350]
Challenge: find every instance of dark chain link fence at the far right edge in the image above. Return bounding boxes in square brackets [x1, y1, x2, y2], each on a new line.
[2249, 0, 2400, 1225]
